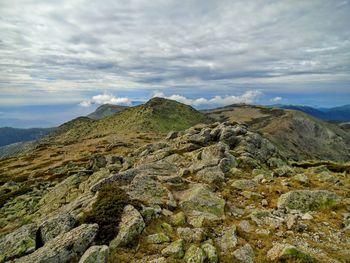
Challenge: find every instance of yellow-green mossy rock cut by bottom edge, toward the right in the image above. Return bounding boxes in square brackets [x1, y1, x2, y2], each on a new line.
[267, 244, 315, 262]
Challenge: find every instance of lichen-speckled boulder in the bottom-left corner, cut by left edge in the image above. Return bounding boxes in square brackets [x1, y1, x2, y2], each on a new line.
[0, 224, 38, 262]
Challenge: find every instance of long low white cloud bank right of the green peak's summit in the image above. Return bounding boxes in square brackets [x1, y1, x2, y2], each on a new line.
[153, 90, 263, 106]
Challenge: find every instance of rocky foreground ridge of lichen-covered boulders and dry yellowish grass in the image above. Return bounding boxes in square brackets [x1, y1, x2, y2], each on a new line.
[0, 123, 350, 263]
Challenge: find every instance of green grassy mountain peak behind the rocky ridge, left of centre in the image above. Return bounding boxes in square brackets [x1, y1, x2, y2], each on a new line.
[50, 98, 211, 143]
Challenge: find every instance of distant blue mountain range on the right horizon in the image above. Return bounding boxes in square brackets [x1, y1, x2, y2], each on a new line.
[272, 104, 350, 122]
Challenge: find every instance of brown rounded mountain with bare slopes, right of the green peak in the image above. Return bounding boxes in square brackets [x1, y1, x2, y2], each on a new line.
[203, 105, 350, 161]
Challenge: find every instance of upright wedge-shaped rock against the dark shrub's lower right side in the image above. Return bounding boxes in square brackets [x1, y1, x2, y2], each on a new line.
[110, 205, 145, 248]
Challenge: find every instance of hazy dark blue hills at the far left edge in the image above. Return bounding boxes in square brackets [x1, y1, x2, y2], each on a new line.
[0, 127, 54, 146]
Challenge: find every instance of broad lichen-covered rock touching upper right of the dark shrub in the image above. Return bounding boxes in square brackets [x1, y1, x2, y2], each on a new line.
[128, 175, 176, 207]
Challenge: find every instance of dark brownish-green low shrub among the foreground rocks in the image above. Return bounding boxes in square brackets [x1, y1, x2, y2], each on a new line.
[81, 183, 137, 244]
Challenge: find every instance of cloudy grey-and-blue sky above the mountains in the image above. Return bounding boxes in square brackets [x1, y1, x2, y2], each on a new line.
[0, 0, 350, 126]
